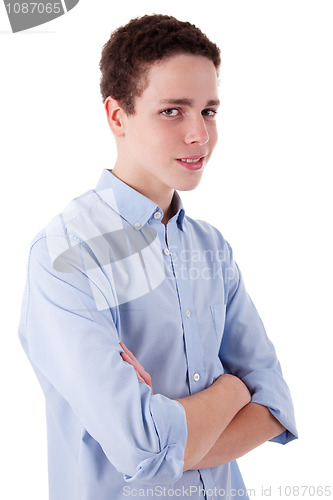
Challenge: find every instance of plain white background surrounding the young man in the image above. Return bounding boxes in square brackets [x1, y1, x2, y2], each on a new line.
[0, 0, 333, 500]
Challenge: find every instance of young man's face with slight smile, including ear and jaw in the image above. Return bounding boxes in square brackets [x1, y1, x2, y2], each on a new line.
[113, 54, 219, 198]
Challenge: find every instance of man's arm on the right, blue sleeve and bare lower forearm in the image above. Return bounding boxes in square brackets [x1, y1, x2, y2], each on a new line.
[217, 244, 297, 446]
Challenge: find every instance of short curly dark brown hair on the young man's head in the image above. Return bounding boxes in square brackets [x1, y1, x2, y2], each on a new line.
[100, 14, 221, 115]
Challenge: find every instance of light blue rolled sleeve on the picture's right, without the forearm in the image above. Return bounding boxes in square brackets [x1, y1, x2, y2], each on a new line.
[220, 240, 297, 444]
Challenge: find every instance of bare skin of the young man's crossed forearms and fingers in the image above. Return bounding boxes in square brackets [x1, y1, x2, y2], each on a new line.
[121, 344, 286, 471]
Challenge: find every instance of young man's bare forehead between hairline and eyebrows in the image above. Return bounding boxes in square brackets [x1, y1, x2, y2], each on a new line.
[139, 54, 218, 101]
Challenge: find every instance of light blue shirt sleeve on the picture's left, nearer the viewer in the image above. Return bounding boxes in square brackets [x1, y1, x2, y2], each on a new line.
[19, 235, 187, 483]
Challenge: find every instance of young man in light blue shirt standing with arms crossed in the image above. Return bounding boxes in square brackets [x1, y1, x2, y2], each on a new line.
[20, 15, 296, 500]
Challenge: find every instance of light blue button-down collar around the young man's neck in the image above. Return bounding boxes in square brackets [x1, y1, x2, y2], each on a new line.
[96, 169, 185, 231]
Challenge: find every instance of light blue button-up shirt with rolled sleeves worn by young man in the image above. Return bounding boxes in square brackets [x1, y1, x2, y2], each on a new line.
[19, 170, 297, 500]
